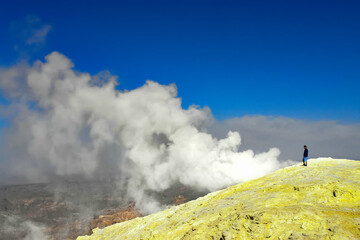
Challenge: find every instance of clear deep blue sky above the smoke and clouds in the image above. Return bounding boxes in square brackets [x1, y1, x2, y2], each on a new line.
[0, 0, 360, 122]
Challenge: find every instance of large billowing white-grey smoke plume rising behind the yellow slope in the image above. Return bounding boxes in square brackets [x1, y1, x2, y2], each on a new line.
[0, 52, 292, 212]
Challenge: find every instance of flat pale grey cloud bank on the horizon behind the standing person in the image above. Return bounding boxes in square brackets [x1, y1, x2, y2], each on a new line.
[211, 116, 360, 161]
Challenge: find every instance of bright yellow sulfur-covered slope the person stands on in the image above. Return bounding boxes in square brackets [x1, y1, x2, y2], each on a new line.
[77, 158, 360, 240]
